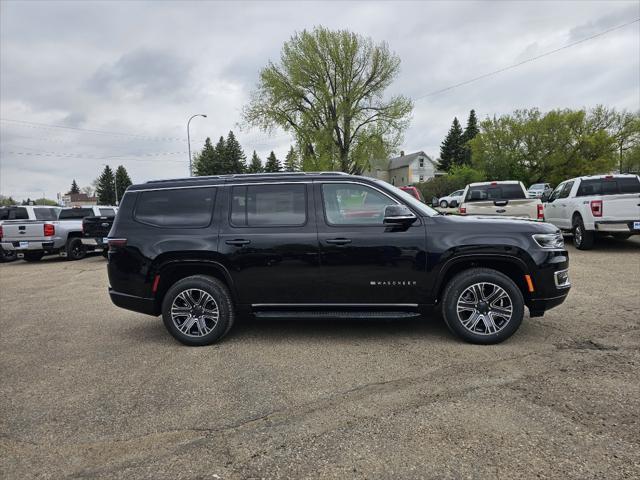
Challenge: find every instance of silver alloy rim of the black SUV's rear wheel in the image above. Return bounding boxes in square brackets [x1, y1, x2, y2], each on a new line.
[171, 288, 220, 337]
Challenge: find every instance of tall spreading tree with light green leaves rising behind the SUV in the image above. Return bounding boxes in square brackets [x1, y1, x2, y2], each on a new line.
[243, 27, 413, 173]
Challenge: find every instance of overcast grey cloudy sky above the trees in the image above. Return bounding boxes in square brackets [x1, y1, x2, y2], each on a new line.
[0, 0, 640, 199]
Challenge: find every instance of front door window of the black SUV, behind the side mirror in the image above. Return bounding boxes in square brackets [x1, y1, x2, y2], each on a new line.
[322, 183, 398, 225]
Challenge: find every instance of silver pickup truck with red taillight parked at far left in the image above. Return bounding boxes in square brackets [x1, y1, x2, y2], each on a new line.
[0, 206, 116, 262]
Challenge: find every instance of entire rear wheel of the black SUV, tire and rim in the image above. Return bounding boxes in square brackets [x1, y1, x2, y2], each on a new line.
[162, 275, 235, 346]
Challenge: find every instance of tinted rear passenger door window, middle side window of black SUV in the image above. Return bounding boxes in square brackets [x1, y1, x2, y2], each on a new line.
[231, 184, 307, 227]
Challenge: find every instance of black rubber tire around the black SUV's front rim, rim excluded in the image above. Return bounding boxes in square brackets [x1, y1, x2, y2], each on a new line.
[442, 269, 524, 345]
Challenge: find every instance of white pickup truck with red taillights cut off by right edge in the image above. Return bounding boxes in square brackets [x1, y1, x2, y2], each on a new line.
[544, 175, 640, 250]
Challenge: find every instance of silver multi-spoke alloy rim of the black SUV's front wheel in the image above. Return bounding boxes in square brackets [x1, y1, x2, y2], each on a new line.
[456, 282, 513, 335]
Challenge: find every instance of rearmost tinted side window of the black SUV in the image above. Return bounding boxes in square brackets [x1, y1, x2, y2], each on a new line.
[134, 188, 216, 228]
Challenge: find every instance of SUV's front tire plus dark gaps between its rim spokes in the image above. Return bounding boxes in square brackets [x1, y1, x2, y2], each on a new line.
[442, 268, 524, 345]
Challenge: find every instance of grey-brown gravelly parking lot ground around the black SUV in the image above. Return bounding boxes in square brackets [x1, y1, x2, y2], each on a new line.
[0, 238, 640, 479]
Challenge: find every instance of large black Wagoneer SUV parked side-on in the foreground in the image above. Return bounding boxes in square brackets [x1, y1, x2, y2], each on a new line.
[108, 172, 570, 345]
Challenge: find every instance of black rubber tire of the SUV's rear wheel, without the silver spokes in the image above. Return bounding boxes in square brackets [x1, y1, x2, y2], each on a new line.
[162, 275, 235, 347]
